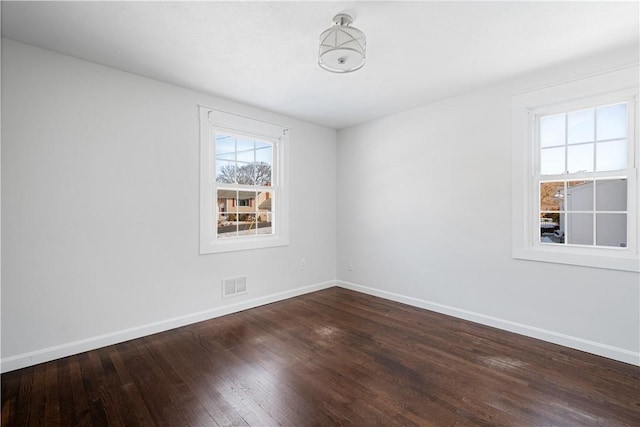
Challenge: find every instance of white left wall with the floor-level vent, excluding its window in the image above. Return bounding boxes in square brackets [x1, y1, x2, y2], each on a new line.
[2, 39, 336, 371]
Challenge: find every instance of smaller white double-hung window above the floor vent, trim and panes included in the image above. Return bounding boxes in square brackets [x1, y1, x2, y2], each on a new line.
[200, 107, 288, 254]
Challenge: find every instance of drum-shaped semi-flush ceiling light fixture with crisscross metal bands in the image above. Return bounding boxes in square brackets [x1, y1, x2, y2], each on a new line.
[318, 13, 367, 73]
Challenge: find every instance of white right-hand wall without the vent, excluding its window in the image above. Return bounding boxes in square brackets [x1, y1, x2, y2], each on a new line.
[337, 48, 640, 364]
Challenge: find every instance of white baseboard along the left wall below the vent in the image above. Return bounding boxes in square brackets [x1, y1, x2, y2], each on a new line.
[0, 280, 336, 373]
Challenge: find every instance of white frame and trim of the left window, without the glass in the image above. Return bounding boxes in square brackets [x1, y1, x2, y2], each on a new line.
[199, 105, 289, 254]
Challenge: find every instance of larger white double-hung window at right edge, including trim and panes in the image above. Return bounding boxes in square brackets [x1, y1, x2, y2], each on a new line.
[513, 67, 640, 271]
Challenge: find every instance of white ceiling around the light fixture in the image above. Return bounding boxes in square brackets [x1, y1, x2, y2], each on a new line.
[2, 1, 640, 129]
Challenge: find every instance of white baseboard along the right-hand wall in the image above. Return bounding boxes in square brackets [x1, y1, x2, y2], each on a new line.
[336, 280, 640, 366]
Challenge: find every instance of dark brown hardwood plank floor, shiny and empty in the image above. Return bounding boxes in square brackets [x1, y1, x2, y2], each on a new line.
[2, 288, 640, 427]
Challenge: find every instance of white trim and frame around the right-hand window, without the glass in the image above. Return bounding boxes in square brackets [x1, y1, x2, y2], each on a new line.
[512, 66, 640, 272]
